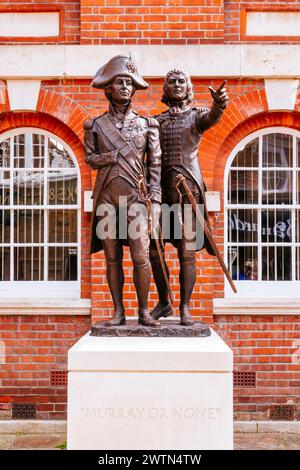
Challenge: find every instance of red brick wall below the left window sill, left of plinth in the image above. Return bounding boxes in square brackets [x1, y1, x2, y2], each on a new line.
[0, 315, 90, 419]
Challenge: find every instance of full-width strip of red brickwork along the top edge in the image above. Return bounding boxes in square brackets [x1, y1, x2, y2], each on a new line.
[0, 0, 300, 44]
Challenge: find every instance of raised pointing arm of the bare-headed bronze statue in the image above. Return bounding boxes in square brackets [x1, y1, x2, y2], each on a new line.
[196, 80, 228, 132]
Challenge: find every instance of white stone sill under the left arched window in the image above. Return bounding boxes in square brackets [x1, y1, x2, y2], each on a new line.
[0, 298, 91, 315]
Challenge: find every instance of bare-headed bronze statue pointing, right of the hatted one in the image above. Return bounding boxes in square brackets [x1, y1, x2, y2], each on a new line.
[150, 69, 228, 326]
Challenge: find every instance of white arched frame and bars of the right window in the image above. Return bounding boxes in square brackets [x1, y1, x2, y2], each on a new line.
[224, 126, 300, 299]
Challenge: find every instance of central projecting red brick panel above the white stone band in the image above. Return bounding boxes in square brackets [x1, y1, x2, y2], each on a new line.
[81, 0, 224, 44]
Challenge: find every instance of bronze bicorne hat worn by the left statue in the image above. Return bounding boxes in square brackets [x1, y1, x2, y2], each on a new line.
[92, 55, 148, 90]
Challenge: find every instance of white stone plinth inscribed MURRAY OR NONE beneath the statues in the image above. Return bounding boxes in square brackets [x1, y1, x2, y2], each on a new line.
[68, 331, 233, 450]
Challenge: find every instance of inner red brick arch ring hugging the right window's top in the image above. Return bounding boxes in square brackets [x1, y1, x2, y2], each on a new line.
[213, 111, 300, 192]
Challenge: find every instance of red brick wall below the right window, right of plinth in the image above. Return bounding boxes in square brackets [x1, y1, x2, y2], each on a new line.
[214, 312, 300, 420]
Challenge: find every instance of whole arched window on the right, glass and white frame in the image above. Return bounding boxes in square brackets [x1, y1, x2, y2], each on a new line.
[225, 128, 300, 297]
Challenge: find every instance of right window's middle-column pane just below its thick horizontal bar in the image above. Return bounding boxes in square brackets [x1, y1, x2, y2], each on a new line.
[261, 209, 292, 243]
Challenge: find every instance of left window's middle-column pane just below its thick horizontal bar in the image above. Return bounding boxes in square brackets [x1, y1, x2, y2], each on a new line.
[14, 209, 44, 243]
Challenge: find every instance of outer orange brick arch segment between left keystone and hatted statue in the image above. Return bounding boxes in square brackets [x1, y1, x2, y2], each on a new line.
[37, 88, 90, 142]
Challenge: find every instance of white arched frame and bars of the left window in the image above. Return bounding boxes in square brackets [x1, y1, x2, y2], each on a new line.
[0, 127, 81, 299]
